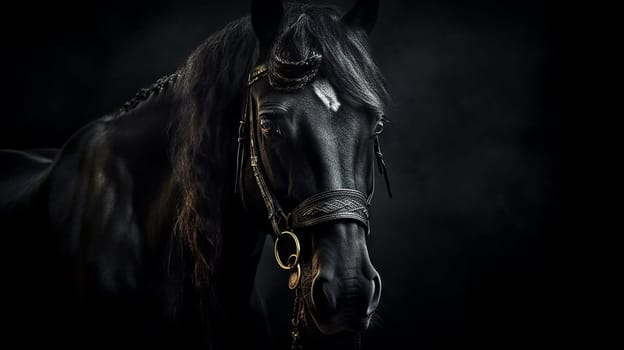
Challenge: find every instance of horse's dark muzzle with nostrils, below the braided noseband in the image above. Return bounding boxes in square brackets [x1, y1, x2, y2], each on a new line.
[306, 221, 381, 335]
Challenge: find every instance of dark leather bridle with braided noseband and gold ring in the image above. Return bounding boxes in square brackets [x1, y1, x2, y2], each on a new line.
[235, 64, 392, 289]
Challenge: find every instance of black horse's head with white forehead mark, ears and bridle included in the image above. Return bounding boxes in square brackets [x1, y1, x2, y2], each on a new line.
[237, 0, 389, 335]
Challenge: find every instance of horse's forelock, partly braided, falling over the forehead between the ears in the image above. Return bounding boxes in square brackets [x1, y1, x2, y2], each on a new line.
[268, 4, 389, 114]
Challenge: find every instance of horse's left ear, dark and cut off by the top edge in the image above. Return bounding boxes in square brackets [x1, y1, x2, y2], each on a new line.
[251, 0, 284, 52]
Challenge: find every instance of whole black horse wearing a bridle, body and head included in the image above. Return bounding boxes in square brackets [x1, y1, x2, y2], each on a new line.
[0, 0, 389, 348]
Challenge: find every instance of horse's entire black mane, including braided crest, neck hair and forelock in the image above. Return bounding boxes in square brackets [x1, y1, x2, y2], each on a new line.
[112, 4, 389, 286]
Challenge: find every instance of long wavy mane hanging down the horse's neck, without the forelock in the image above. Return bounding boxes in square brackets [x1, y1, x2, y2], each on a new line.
[170, 18, 255, 285]
